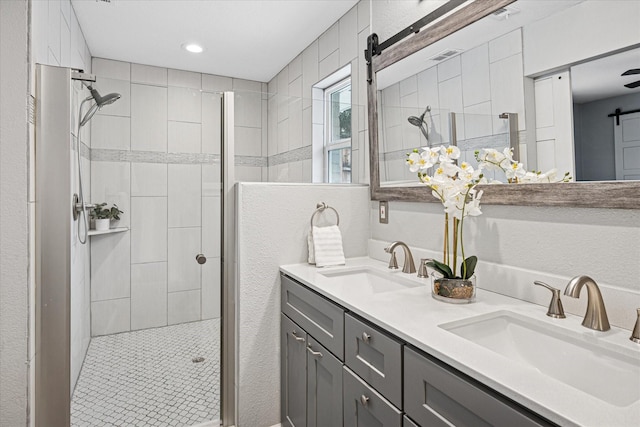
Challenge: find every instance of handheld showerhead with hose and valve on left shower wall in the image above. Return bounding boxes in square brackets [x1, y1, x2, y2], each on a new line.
[73, 79, 121, 245]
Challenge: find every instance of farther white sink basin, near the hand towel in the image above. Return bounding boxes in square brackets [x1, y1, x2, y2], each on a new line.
[320, 267, 424, 294]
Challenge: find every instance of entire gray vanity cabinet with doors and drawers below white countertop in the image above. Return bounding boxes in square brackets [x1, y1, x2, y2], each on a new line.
[281, 275, 554, 427]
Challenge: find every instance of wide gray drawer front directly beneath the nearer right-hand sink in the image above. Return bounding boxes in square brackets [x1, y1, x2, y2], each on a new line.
[404, 347, 553, 427]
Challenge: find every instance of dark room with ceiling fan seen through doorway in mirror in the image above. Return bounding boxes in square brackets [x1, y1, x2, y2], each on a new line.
[571, 49, 640, 181]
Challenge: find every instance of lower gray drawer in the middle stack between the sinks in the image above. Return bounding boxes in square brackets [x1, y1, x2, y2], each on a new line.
[342, 367, 402, 427]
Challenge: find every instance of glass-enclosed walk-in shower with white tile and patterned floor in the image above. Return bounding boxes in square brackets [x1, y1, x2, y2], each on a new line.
[34, 62, 235, 427]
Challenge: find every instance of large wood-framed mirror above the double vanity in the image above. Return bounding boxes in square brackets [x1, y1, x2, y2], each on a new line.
[368, 0, 640, 209]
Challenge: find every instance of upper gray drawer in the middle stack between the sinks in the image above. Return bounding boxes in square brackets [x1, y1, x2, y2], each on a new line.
[344, 314, 402, 409]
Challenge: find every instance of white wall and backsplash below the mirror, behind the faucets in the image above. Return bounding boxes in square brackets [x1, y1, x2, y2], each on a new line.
[369, 202, 640, 329]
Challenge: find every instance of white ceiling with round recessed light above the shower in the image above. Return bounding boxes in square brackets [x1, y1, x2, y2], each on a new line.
[72, 0, 358, 82]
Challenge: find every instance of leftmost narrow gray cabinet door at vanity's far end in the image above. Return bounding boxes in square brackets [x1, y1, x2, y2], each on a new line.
[280, 314, 307, 427]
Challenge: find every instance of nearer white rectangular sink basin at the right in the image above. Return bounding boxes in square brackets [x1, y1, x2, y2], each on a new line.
[439, 311, 640, 407]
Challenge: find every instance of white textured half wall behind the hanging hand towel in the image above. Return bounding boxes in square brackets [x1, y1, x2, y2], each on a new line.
[236, 183, 369, 427]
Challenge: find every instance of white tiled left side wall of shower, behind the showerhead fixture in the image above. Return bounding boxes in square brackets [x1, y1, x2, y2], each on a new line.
[29, 0, 91, 398]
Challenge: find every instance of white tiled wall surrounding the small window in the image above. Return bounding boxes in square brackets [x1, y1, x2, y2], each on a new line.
[268, 1, 369, 183]
